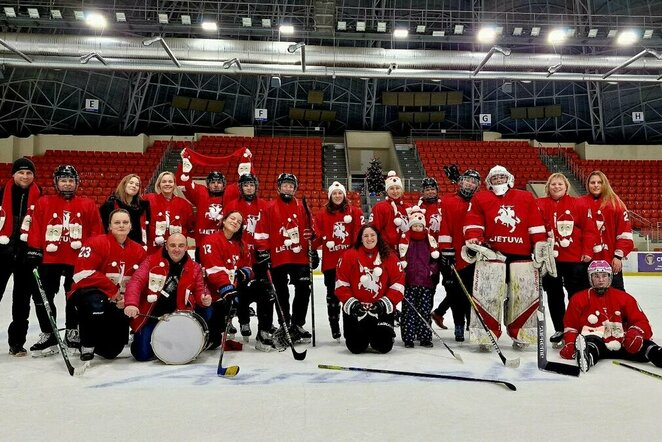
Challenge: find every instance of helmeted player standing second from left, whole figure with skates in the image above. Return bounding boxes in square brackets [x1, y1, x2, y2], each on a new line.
[27, 164, 103, 356]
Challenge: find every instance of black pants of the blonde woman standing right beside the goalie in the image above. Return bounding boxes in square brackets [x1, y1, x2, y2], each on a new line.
[542, 262, 590, 332]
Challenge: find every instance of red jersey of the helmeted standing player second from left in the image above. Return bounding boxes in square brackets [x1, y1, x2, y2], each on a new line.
[28, 194, 103, 265]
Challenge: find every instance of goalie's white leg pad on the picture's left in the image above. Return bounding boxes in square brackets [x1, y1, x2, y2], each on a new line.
[469, 261, 506, 346]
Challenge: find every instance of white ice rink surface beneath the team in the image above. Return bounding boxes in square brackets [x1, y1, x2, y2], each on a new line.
[0, 275, 662, 442]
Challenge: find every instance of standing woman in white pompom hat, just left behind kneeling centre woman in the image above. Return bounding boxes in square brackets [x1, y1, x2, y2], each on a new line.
[313, 181, 365, 339]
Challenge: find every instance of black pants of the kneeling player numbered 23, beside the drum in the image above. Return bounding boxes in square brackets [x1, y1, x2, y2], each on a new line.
[69, 289, 129, 359]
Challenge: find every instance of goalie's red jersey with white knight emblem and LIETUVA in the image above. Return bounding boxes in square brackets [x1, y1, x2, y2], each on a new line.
[464, 189, 547, 255]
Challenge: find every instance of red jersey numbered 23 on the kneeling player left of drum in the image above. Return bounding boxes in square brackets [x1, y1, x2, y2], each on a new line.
[67, 233, 147, 299]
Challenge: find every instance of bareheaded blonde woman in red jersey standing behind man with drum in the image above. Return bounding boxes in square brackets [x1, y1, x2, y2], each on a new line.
[145, 171, 193, 254]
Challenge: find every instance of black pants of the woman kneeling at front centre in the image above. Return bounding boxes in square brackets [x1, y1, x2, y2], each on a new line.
[343, 313, 395, 354]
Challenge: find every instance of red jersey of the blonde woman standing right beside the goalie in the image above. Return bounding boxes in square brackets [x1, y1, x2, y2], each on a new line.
[538, 195, 600, 262]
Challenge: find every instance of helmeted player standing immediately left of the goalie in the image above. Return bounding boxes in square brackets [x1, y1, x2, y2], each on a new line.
[432, 169, 480, 342]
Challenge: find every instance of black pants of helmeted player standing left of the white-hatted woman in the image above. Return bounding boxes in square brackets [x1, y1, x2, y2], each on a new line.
[271, 264, 311, 326]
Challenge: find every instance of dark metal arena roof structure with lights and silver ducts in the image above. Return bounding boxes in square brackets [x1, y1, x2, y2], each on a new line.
[0, 0, 662, 144]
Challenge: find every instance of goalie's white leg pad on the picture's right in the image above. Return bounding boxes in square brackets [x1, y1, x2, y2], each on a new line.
[504, 261, 540, 344]
